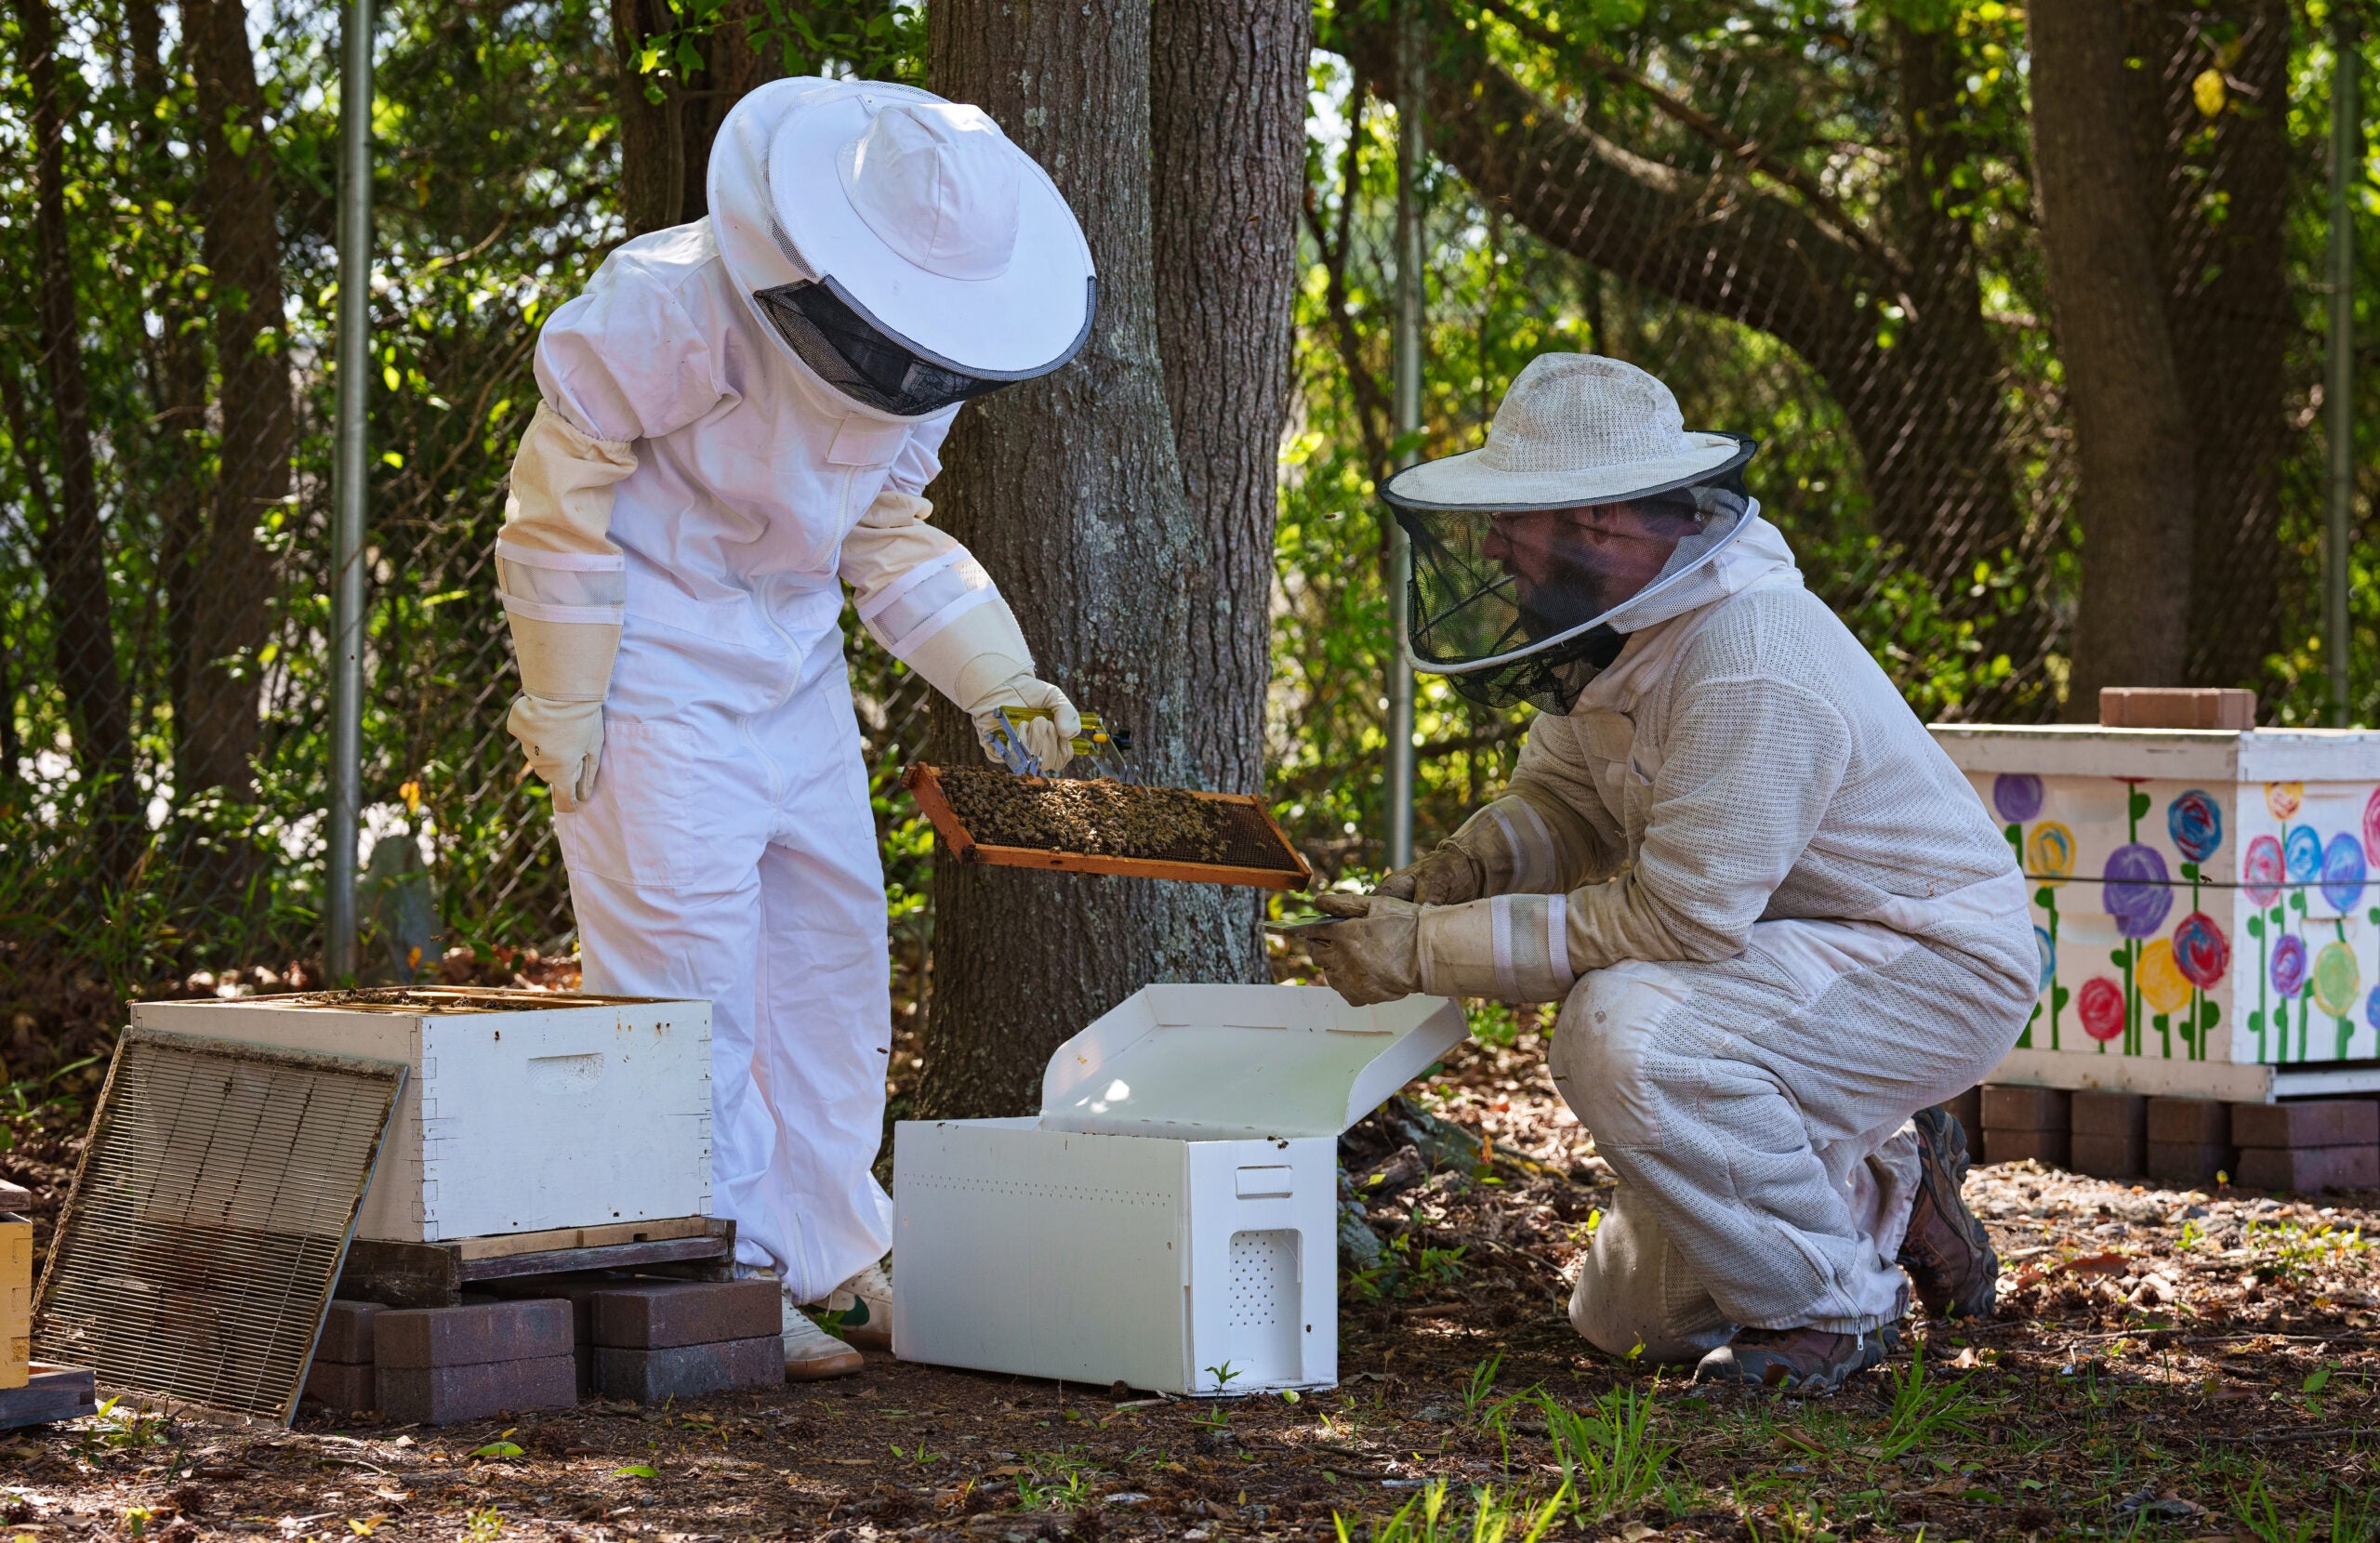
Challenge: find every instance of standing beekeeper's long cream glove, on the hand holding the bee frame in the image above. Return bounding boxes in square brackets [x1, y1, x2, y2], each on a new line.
[838, 488, 1083, 772]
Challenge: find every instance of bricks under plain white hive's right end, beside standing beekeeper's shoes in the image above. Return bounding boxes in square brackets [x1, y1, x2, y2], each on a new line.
[586, 1281, 786, 1403]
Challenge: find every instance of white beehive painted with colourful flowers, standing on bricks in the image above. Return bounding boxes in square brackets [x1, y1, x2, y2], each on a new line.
[1935, 724, 2380, 1101]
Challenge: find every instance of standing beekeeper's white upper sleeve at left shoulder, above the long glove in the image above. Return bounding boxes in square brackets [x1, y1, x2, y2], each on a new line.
[536, 253, 728, 441]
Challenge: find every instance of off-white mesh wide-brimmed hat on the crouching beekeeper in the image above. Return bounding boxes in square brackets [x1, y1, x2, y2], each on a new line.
[1382, 355, 1756, 509]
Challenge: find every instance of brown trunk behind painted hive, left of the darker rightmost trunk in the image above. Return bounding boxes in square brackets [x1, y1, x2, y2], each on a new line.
[2028, 0, 2194, 719]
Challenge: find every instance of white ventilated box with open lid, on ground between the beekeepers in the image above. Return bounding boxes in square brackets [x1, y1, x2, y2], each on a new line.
[892, 986, 1466, 1395]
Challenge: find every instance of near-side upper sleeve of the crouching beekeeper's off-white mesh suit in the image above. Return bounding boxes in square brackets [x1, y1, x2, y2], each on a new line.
[1564, 677, 1852, 974]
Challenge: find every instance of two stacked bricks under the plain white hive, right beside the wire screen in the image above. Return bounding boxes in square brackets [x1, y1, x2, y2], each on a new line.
[371, 1298, 578, 1424]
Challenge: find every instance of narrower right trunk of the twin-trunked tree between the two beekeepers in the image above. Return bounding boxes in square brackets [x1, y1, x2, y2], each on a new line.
[1149, 0, 1314, 981]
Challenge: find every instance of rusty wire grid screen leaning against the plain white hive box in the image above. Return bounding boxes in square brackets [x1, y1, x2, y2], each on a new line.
[33, 1029, 404, 1421]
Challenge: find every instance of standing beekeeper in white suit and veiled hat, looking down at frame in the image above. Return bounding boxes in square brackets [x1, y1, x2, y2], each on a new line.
[495, 79, 1092, 1378]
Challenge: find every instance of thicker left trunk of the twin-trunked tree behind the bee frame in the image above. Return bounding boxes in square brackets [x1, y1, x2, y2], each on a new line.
[919, 0, 1247, 1119]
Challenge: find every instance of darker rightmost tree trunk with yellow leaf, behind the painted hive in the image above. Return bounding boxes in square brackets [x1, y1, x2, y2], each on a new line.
[2130, 0, 2294, 688]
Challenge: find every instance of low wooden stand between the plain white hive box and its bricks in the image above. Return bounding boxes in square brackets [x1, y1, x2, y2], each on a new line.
[338, 1217, 735, 1307]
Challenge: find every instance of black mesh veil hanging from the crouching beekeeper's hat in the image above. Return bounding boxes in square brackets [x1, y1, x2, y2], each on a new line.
[1387, 441, 1759, 712]
